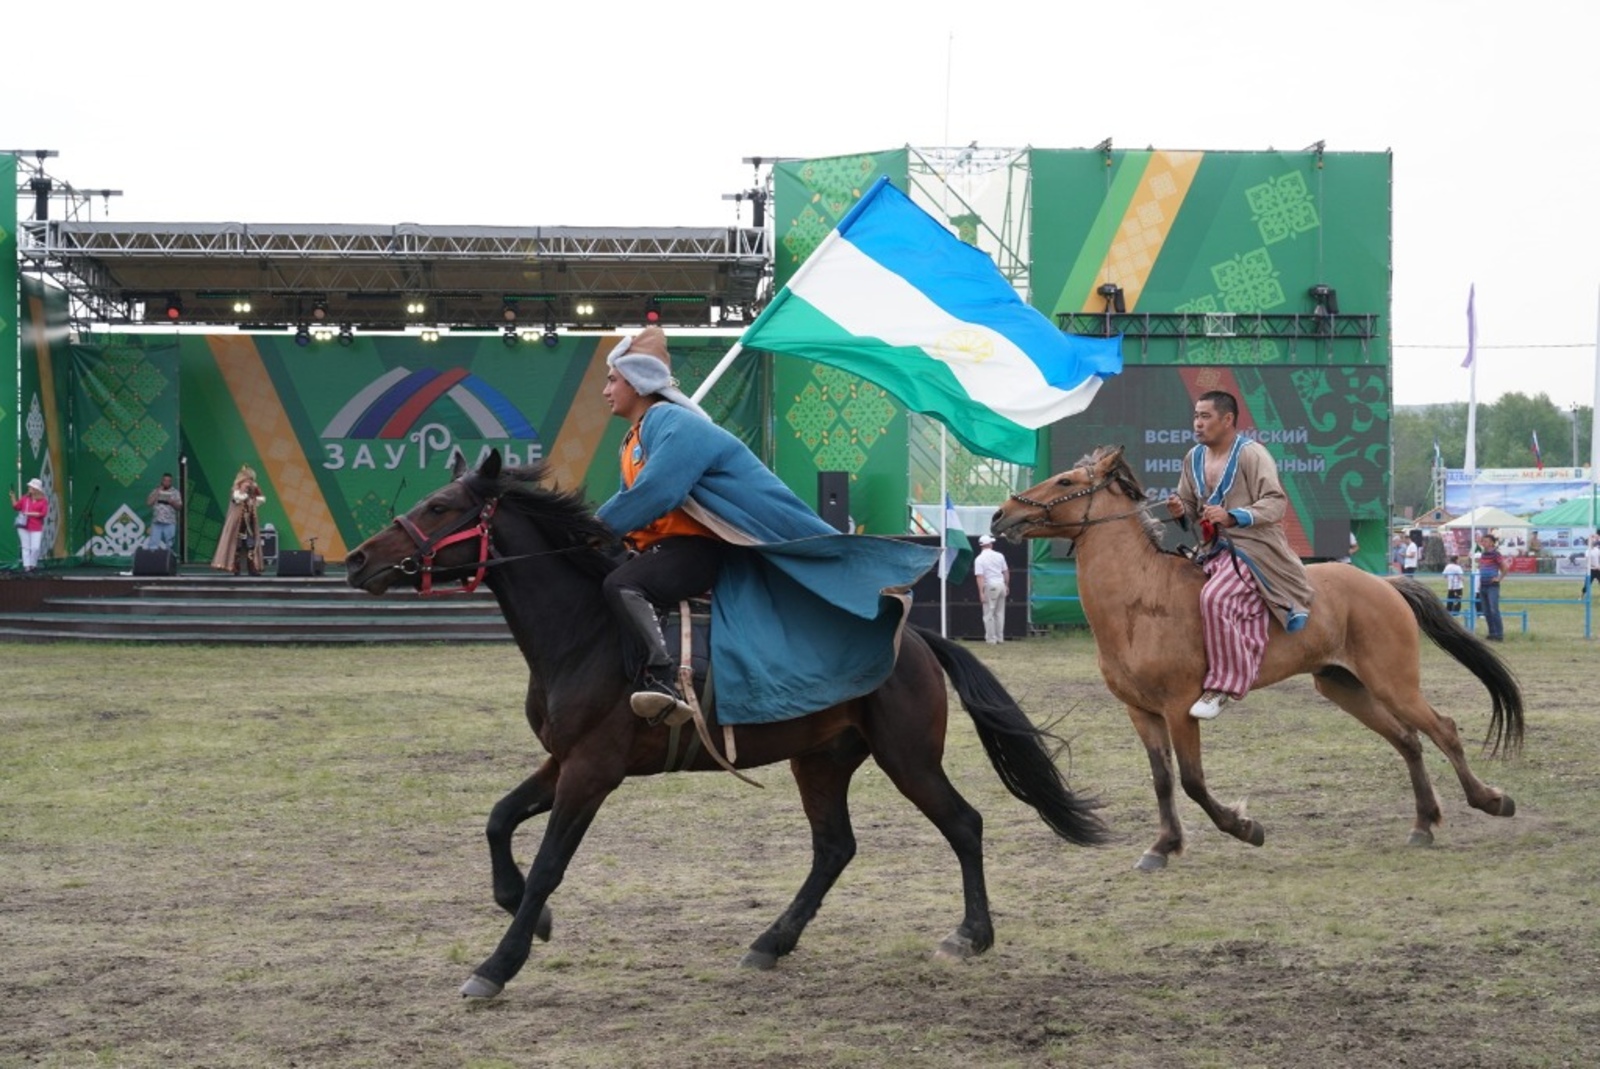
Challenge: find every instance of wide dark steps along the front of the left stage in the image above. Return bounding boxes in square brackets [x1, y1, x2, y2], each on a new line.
[0, 570, 510, 643]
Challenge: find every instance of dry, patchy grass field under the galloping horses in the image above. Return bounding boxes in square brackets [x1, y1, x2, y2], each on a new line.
[0, 608, 1600, 1069]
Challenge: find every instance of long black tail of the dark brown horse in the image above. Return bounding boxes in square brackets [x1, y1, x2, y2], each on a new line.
[914, 627, 1110, 847]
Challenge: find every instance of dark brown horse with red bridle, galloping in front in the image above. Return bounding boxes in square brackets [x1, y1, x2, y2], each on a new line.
[346, 453, 1106, 999]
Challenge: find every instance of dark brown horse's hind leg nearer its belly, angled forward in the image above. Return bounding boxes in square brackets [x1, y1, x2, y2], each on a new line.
[739, 733, 867, 968]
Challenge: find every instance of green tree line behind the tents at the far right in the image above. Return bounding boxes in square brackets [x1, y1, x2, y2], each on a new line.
[1390, 394, 1594, 514]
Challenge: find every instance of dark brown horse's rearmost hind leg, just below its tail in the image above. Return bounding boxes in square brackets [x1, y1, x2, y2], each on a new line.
[864, 704, 995, 957]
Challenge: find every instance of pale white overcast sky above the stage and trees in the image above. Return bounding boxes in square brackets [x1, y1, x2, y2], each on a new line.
[0, 0, 1600, 408]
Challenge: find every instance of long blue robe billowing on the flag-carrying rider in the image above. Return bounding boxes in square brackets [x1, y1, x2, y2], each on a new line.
[597, 403, 939, 723]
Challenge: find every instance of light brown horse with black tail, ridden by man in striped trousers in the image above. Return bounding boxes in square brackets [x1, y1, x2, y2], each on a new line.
[990, 446, 1523, 871]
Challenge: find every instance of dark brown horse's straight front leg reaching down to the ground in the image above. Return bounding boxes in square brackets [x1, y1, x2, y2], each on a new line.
[461, 754, 624, 999]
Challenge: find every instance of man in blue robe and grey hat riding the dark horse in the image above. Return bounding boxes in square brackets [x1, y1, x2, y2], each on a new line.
[597, 326, 938, 723]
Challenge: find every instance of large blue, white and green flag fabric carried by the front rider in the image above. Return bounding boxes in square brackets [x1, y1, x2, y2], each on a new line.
[739, 178, 1122, 464]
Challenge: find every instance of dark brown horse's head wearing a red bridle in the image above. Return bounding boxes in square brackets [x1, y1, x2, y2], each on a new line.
[344, 450, 501, 594]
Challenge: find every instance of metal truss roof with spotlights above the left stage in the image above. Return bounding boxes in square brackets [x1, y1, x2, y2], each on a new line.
[19, 221, 771, 328]
